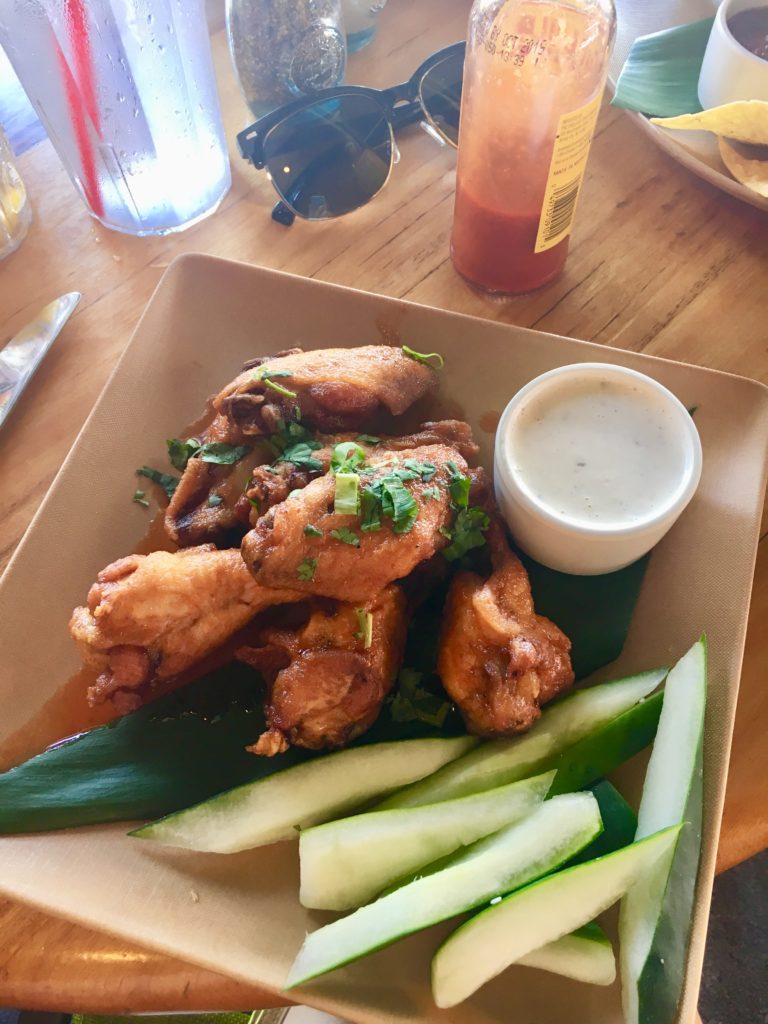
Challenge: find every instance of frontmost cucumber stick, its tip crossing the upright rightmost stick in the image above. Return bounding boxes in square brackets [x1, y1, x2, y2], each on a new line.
[432, 823, 679, 1008]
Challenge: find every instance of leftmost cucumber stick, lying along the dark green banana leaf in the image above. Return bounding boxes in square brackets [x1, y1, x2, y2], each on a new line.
[130, 736, 476, 853]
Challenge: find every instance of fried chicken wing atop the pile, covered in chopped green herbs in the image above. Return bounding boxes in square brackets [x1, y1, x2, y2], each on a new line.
[242, 444, 467, 604]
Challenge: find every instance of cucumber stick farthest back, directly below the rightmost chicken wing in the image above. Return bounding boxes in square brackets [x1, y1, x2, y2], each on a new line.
[375, 669, 667, 810]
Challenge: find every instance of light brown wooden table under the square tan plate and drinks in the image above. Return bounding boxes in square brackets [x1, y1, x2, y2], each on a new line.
[0, 0, 768, 1013]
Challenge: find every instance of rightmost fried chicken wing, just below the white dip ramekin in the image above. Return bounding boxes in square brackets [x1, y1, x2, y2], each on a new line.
[437, 521, 573, 736]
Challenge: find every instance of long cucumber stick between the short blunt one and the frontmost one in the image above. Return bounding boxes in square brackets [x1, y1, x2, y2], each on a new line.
[286, 793, 601, 988]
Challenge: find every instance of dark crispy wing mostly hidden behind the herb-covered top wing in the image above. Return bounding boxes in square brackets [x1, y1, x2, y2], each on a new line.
[239, 420, 479, 526]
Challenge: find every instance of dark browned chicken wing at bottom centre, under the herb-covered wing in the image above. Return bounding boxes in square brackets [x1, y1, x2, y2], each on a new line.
[238, 586, 406, 757]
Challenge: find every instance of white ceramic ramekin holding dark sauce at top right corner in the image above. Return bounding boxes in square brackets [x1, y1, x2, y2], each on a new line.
[698, 0, 768, 109]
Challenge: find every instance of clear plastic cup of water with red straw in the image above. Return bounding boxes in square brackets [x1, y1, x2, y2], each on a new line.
[0, 0, 230, 234]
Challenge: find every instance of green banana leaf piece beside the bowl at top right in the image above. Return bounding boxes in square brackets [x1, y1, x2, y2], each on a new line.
[611, 17, 715, 118]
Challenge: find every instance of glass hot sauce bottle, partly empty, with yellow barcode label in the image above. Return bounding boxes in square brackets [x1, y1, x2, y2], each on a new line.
[452, 0, 615, 294]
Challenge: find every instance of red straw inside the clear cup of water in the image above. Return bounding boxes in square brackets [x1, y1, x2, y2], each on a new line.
[55, 0, 104, 217]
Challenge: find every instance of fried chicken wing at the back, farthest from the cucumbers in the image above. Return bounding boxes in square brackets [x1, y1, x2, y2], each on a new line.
[213, 345, 436, 436]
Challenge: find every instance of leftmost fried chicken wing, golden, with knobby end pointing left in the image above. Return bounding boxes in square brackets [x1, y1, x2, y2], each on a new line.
[70, 545, 302, 712]
